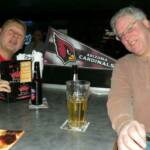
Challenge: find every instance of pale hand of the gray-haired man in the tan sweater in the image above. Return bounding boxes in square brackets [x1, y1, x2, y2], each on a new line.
[118, 120, 146, 150]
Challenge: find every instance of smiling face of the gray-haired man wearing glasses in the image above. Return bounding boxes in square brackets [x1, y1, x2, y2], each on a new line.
[116, 16, 150, 56]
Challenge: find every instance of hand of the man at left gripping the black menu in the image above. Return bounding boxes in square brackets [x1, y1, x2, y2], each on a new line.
[0, 80, 11, 93]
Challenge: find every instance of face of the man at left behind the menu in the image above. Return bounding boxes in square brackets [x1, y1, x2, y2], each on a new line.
[0, 22, 25, 55]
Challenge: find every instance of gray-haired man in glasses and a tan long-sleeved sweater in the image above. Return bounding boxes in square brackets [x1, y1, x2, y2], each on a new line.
[107, 6, 150, 150]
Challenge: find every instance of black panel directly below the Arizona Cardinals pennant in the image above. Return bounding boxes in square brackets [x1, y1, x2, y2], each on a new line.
[43, 65, 112, 88]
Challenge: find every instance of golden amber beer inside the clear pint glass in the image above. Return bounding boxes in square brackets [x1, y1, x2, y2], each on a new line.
[67, 97, 87, 127]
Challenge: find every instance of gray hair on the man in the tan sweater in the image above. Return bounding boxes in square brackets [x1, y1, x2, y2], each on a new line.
[110, 6, 147, 34]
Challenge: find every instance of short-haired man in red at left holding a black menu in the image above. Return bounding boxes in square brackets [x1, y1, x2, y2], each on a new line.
[0, 19, 27, 92]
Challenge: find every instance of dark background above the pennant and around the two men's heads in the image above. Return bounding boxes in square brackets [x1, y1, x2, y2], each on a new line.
[0, 0, 150, 58]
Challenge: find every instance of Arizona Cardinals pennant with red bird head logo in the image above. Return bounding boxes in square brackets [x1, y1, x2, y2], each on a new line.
[44, 27, 116, 69]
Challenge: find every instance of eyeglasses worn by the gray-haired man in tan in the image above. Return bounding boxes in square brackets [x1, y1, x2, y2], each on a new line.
[116, 20, 137, 41]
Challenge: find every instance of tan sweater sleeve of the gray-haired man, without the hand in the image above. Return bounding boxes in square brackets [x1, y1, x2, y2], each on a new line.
[107, 61, 133, 133]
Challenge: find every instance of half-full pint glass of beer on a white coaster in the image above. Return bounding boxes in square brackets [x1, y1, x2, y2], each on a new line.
[66, 80, 90, 129]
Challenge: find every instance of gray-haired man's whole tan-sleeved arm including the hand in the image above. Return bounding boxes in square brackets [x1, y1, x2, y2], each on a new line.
[107, 59, 146, 150]
